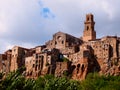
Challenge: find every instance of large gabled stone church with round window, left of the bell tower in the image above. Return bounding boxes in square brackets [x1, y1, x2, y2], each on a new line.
[46, 32, 82, 50]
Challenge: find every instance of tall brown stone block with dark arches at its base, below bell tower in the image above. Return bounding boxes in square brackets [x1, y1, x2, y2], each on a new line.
[71, 45, 99, 80]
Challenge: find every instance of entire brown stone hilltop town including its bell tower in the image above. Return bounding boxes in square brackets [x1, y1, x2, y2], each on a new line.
[0, 14, 120, 80]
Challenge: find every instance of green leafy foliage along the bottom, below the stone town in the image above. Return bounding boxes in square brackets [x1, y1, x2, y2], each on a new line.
[0, 68, 120, 90]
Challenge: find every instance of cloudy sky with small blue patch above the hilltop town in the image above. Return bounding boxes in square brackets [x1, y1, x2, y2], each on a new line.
[0, 0, 120, 53]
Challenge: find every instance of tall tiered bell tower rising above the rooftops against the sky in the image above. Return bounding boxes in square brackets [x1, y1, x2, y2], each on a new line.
[83, 14, 96, 41]
